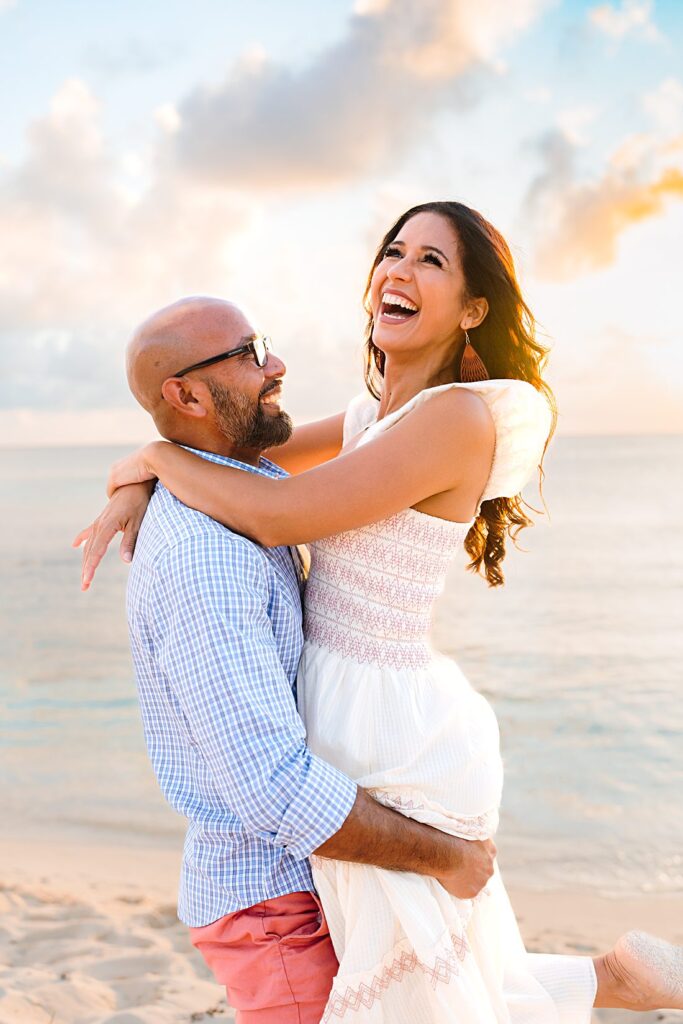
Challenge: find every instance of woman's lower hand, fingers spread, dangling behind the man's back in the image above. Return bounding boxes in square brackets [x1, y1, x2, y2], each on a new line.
[73, 481, 156, 590]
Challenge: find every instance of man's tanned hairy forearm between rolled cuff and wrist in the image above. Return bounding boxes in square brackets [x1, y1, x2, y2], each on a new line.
[315, 786, 467, 877]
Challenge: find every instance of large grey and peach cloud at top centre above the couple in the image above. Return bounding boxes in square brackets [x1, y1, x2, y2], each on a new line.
[170, 0, 547, 188]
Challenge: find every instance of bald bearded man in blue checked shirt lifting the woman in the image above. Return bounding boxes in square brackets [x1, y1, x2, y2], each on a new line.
[84, 298, 496, 1024]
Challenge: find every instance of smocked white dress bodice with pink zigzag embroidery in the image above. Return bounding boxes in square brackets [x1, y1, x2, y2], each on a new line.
[304, 509, 470, 669]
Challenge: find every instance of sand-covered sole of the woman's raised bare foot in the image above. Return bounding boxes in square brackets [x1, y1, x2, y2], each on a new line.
[614, 932, 683, 1010]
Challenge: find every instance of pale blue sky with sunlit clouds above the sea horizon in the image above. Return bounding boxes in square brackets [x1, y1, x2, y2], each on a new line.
[0, 0, 683, 445]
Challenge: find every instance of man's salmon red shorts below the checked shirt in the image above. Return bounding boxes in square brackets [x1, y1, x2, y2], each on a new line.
[189, 893, 338, 1024]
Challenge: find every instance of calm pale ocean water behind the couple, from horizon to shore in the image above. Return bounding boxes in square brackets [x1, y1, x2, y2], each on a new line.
[0, 437, 683, 893]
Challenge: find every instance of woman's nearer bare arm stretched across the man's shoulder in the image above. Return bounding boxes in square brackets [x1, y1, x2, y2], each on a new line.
[104, 389, 495, 547]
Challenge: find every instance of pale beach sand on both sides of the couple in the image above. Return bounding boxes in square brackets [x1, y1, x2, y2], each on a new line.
[0, 840, 683, 1024]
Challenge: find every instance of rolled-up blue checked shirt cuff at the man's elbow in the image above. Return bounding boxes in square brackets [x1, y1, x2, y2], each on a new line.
[274, 754, 357, 860]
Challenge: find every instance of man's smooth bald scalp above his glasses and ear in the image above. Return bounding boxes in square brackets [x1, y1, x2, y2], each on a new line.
[126, 297, 254, 419]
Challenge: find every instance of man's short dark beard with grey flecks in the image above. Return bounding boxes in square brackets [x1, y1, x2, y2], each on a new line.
[206, 377, 294, 452]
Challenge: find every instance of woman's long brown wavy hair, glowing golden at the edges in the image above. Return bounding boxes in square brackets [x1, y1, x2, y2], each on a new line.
[364, 202, 557, 587]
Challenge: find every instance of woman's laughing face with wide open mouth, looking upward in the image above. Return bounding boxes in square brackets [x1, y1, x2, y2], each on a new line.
[370, 213, 468, 353]
